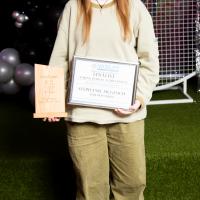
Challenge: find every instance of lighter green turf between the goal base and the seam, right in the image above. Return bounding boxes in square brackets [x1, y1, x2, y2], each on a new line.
[145, 103, 200, 157]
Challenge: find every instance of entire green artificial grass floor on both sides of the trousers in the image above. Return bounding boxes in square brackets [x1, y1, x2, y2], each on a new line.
[0, 81, 200, 200]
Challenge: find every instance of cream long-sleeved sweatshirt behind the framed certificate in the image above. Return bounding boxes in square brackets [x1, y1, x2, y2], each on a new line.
[49, 0, 159, 124]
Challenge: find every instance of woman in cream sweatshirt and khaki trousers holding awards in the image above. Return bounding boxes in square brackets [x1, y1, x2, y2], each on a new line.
[45, 0, 159, 200]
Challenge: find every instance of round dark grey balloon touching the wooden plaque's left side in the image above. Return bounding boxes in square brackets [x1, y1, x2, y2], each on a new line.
[14, 63, 34, 86]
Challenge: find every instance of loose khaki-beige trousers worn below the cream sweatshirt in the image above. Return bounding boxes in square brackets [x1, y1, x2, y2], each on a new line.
[67, 120, 146, 200]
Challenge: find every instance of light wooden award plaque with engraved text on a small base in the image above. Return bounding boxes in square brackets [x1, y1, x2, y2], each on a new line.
[33, 64, 67, 118]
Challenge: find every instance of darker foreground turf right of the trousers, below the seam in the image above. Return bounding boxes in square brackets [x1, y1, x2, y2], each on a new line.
[145, 153, 200, 200]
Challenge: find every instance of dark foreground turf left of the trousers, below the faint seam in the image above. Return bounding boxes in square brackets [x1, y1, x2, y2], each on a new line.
[0, 158, 75, 200]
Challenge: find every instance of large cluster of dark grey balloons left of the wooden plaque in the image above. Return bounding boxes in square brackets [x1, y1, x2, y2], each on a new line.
[0, 48, 34, 103]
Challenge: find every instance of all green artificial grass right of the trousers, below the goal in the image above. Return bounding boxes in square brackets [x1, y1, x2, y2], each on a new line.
[145, 103, 200, 200]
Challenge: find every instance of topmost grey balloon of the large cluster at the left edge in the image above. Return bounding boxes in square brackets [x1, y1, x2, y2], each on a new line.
[0, 48, 20, 66]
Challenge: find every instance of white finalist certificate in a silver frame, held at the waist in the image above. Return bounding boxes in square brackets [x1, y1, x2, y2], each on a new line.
[68, 56, 138, 109]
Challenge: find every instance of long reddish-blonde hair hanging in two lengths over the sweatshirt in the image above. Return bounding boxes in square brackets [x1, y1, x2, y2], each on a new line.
[78, 0, 131, 43]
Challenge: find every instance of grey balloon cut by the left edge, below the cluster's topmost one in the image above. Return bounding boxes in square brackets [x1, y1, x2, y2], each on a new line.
[0, 60, 14, 83]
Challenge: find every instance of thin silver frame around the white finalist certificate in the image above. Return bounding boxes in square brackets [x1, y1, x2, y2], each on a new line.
[67, 56, 139, 109]
